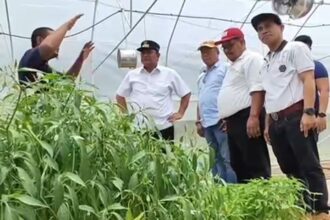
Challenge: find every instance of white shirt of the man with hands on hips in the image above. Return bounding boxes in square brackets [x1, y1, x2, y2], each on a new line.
[116, 66, 190, 130]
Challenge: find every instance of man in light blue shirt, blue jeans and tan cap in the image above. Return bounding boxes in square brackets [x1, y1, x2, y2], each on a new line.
[196, 41, 237, 183]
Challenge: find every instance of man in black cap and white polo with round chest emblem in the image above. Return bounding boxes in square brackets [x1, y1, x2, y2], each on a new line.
[252, 13, 328, 219]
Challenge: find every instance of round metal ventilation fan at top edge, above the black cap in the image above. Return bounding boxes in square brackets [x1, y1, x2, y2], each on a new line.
[272, 0, 314, 19]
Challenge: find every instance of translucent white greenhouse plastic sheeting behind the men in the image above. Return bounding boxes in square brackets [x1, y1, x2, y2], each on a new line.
[0, 0, 330, 98]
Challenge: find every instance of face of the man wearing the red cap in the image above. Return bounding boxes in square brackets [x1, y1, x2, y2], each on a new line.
[222, 38, 245, 61]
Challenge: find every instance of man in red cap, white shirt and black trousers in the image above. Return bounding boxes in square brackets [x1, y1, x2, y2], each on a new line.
[218, 28, 271, 183]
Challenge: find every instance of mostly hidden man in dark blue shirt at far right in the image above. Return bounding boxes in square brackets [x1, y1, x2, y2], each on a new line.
[295, 35, 329, 133]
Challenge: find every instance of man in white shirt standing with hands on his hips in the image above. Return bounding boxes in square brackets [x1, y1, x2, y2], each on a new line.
[116, 40, 191, 140]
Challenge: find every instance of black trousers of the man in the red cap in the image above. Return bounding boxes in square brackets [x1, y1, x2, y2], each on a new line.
[226, 108, 271, 183]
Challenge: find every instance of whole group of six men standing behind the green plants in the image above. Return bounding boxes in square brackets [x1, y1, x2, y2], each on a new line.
[19, 13, 329, 219]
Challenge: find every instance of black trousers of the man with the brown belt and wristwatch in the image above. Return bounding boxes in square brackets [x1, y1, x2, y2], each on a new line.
[269, 113, 328, 212]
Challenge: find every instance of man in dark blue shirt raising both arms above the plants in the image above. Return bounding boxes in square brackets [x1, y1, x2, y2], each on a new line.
[18, 15, 94, 84]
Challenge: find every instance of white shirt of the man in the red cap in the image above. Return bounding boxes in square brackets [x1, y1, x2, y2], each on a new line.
[218, 50, 264, 119]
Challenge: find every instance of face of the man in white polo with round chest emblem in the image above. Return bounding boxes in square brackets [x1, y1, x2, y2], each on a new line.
[257, 20, 284, 46]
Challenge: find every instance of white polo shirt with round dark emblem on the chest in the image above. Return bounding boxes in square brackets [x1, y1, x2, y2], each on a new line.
[261, 42, 314, 114]
